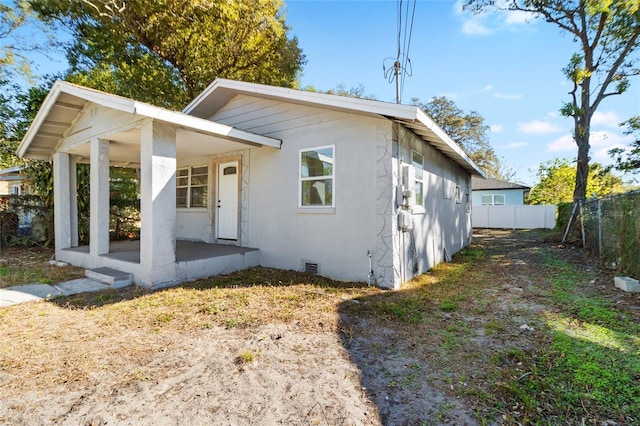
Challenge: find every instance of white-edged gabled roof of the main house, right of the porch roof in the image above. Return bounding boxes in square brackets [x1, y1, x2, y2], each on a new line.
[183, 79, 485, 177]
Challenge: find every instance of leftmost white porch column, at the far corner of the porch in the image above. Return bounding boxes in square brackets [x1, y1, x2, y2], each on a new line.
[53, 152, 72, 251]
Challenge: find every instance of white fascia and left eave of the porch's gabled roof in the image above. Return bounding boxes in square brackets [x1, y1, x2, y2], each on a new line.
[17, 80, 281, 159]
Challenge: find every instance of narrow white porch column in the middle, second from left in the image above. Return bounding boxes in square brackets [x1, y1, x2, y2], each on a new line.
[89, 138, 109, 256]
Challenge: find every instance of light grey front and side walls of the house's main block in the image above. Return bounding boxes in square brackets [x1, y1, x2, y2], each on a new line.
[211, 96, 471, 288]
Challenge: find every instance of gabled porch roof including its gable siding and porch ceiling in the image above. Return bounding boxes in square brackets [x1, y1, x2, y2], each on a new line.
[17, 81, 282, 162]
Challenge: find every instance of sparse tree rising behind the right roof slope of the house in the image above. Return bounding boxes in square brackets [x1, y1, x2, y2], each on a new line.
[411, 96, 514, 180]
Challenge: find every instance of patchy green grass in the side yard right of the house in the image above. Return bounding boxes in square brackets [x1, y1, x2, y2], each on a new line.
[348, 233, 640, 424]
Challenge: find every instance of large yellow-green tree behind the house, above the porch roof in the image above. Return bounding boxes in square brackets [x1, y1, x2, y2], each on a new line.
[30, 0, 305, 107]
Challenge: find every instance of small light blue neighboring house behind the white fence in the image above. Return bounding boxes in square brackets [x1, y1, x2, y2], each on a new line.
[471, 177, 531, 206]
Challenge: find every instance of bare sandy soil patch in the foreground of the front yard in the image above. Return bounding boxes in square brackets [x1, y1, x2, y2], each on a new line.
[0, 325, 475, 425]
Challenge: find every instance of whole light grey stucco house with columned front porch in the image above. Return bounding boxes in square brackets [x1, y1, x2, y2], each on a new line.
[18, 79, 483, 288]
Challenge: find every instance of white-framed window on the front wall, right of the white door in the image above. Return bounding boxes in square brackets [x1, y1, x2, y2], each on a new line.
[298, 145, 335, 207]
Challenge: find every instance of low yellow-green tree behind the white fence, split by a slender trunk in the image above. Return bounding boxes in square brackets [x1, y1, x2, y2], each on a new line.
[529, 158, 624, 204]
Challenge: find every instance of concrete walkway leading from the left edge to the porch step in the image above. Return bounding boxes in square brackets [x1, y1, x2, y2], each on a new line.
[0, 278, 113, 308]
